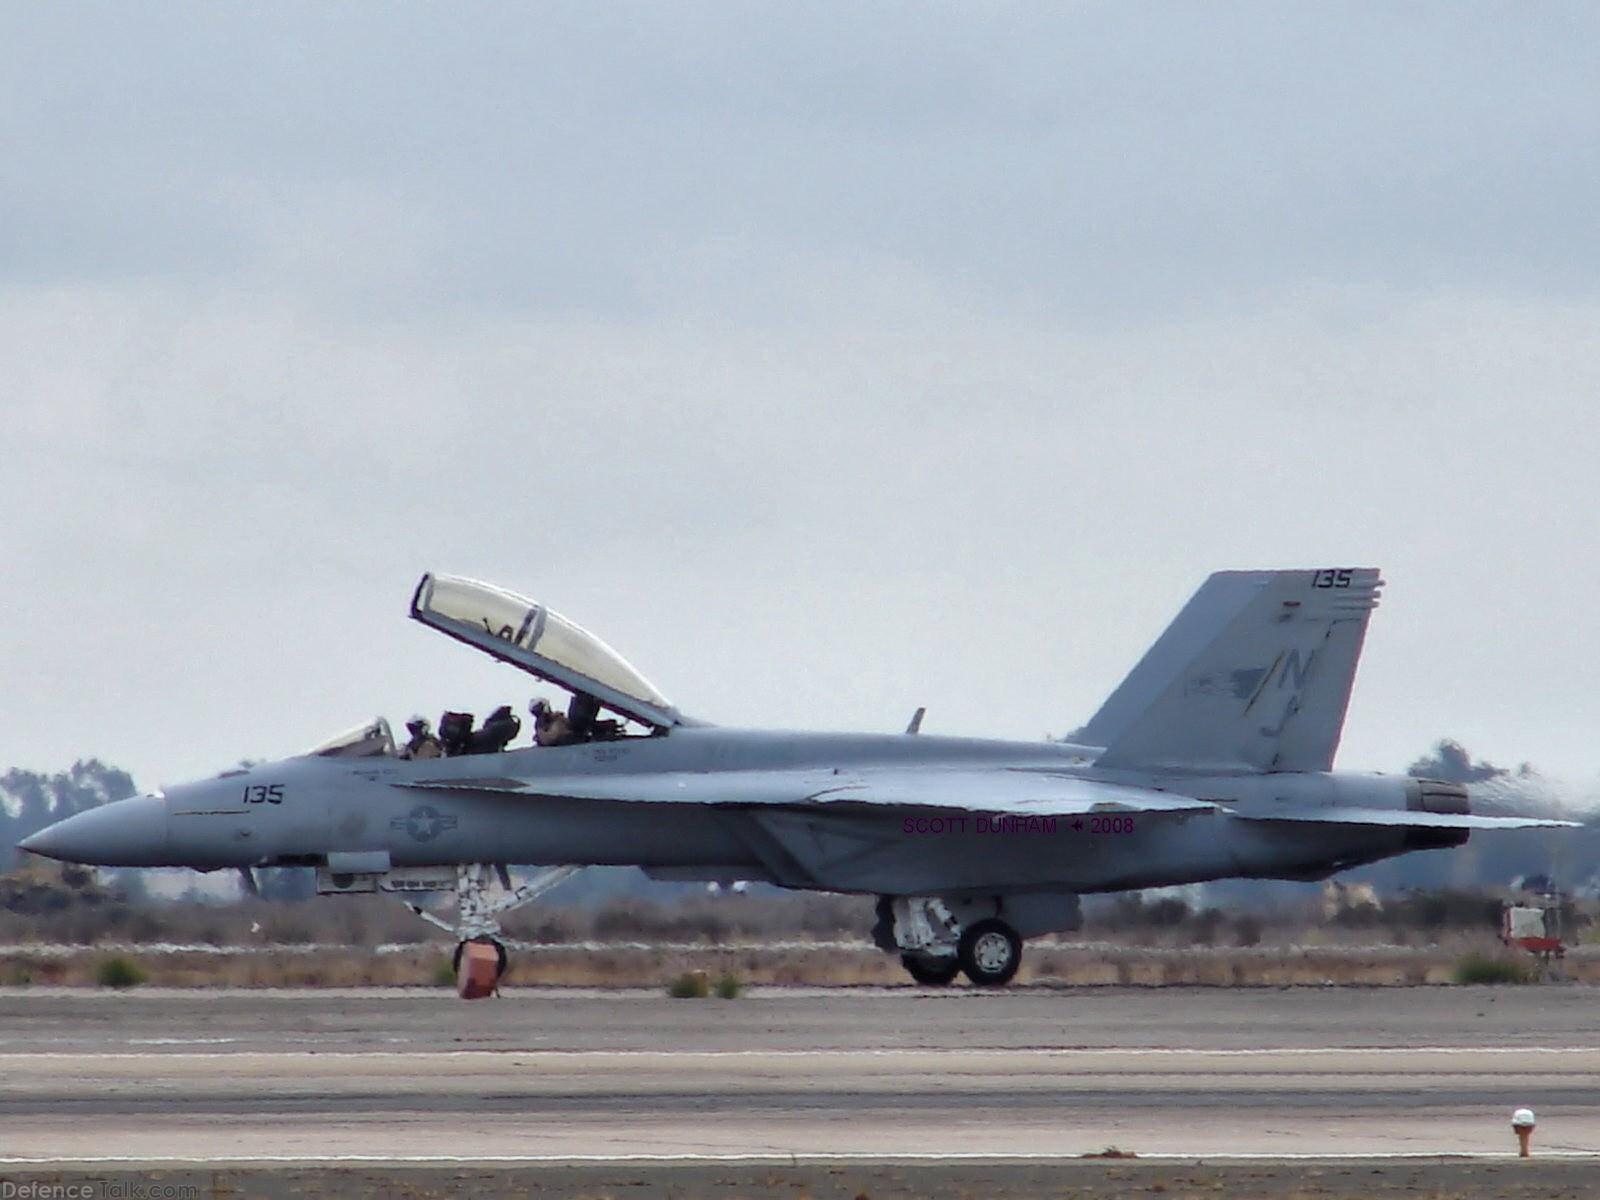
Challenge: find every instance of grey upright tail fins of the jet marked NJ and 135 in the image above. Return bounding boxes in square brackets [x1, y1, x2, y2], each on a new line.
[1080, 568, 1382, 771]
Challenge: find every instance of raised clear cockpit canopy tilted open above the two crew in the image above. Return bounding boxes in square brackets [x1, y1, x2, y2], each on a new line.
[411, 574, 683, 730]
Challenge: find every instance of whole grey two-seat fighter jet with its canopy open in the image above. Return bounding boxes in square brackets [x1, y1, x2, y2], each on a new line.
[21, 568, 1573, 997]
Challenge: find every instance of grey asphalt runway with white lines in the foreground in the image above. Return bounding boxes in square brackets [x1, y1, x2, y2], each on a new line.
[0, 986, 1600, 1195]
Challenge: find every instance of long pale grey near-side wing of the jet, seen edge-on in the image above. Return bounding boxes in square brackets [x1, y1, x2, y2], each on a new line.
[396, 768, 1218, 816]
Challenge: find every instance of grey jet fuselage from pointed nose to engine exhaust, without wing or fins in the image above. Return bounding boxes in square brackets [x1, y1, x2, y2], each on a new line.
[18, 726, 1422, 894]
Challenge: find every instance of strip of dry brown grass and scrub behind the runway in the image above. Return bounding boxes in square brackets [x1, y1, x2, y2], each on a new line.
[0, 870, 1600, 989]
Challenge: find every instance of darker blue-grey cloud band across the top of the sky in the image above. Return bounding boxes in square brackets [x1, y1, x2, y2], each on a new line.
[5, 5, 1600, 312]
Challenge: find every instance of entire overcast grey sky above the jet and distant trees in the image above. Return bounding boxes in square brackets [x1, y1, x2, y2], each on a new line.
[0, 0, 1600, 787]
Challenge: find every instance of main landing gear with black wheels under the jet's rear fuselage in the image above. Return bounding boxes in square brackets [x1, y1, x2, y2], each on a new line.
[874, 896, 1022, 987]
